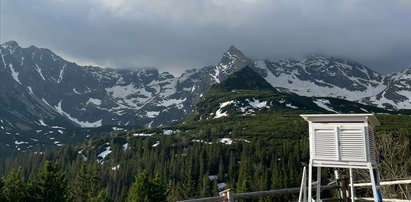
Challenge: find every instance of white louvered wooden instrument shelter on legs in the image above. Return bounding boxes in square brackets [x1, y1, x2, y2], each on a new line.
[301, 114, 382, 202]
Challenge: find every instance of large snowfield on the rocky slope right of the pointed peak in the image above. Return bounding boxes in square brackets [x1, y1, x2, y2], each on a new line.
[254, 58, 386, 101]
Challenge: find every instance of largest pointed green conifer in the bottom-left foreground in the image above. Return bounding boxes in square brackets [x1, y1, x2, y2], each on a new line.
[30, 161, 68, 201]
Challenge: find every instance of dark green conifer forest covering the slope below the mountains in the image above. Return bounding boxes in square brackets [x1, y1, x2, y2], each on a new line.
[0, 114, 411, 201]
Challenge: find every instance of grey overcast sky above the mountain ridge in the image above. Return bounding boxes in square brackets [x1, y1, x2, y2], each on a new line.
[0, 0, 411, 74]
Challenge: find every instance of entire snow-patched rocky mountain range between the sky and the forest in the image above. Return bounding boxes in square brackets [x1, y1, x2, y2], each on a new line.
[0, 41, 411, 153]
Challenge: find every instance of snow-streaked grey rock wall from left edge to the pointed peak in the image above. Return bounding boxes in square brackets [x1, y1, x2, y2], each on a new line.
[0, 41, 250, 132]
